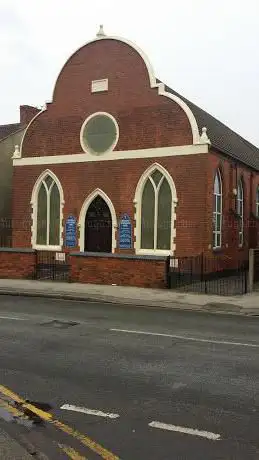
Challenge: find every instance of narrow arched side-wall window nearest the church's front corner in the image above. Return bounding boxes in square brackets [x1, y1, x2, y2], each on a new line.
[213, 170, 222, 248]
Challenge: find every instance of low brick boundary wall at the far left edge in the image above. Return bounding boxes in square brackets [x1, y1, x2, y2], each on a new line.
[0, 248, 36, 279]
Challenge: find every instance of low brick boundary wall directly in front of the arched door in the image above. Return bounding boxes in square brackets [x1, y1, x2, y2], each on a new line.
[69, 255, 168, 288]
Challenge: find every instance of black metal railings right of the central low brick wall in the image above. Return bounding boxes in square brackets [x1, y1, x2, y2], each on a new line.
[166, 254, 249, 296]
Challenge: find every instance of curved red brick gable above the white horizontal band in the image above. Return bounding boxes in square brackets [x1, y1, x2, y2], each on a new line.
[22, 40, 192, 157]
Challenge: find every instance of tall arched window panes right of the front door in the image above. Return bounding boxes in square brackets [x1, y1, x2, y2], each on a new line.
[140, 169, 172, 251]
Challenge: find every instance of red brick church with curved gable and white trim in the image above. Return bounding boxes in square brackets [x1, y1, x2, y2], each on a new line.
[13, 27, 259, 284]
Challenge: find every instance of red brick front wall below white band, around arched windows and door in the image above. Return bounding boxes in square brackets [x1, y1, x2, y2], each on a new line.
[13, 154, 208, 255]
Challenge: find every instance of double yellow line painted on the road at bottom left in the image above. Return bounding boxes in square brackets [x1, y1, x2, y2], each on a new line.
[0, 385, 119, 460]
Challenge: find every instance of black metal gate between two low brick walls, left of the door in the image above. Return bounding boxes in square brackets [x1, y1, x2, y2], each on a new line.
[34, 251, 70, 281]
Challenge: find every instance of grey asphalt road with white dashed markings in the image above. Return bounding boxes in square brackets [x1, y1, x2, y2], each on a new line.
[0, 296, 259, 460]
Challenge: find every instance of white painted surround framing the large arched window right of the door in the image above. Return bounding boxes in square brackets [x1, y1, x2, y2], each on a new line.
[134, 163, 178, 255]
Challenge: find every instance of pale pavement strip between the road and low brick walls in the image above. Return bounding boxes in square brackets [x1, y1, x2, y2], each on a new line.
[0, 279, 259, 316]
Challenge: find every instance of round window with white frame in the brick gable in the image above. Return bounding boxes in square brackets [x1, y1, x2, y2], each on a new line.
[81, 114, 118, 155]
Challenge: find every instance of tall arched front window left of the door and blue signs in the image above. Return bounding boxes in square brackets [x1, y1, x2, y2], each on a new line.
[32, 174, 61, 247]
